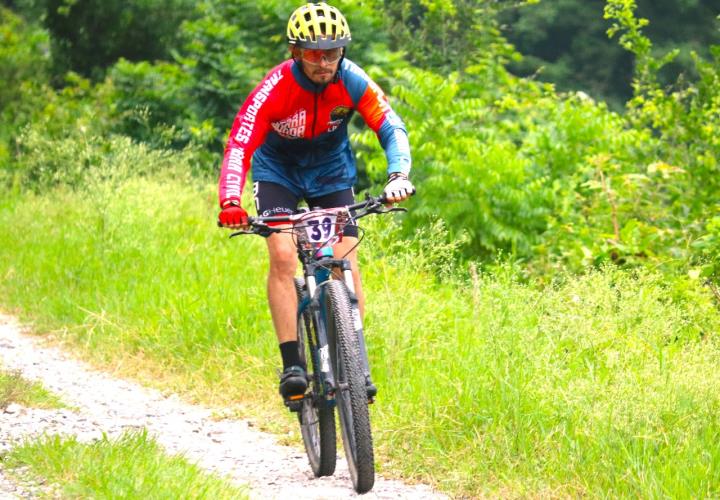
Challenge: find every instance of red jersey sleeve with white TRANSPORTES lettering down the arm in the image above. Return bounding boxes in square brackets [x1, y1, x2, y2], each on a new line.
[218, 67, 284, 206]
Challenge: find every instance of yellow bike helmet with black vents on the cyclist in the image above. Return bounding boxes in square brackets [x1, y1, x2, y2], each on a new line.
[287, 3, 350, 49]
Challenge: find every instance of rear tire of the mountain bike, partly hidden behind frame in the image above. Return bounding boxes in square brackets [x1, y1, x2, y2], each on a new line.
[295, 278, 337, 477]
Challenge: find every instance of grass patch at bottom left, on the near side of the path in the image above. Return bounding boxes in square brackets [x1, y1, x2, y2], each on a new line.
[4, 432, 247, 500]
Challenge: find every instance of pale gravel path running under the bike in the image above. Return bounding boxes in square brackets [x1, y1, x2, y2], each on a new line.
[0, 315, 444, 499]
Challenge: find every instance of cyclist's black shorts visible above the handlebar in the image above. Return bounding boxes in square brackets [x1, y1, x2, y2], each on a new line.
[253, 181, 358, 238]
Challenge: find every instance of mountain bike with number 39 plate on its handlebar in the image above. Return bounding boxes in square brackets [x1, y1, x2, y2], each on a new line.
[231, 196, 405, 493]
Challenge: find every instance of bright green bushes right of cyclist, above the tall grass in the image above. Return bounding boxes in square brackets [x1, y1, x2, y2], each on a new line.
[353, 0, 720, 280]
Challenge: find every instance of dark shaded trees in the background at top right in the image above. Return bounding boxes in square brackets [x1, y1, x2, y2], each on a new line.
[500, 0, 720, 109]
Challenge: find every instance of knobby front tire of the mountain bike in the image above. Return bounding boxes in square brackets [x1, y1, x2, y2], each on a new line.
[324, 280, 375, 494]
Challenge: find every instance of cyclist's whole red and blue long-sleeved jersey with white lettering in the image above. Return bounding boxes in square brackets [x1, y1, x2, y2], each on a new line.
[219, 59, 411, 204]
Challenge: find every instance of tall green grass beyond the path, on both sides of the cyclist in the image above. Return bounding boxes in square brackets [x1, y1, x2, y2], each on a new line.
[0, 171, 720, 497]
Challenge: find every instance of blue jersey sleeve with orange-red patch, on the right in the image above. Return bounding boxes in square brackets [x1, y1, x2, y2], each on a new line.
[345, 61, 412, 174]
